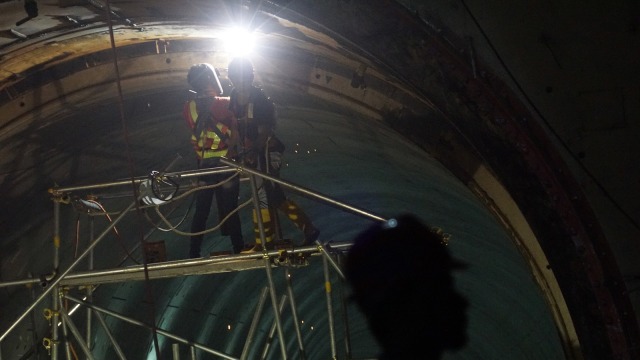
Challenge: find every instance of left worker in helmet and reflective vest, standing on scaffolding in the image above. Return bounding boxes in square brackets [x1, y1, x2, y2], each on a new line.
[183, 64, 244, 258]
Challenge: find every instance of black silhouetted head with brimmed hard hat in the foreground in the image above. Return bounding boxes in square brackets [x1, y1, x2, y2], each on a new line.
[345, 215, 468, 359]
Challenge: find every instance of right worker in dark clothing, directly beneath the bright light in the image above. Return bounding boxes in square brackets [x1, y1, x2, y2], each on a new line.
[228, 58, 320, 252]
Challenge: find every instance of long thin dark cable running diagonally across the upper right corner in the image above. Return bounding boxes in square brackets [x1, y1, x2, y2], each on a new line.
[460, 0, 640, 230]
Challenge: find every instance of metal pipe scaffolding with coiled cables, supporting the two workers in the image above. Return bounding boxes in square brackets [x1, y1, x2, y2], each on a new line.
[0, 159, 385, 360]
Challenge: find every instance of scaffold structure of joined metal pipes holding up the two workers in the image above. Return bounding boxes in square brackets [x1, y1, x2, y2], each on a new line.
[0, 159, 376, 360]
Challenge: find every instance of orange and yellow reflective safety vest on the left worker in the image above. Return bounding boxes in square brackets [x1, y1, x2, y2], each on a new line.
[184, 97, 233, 159]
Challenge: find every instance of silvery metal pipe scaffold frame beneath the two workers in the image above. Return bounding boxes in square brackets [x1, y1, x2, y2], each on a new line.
[0, 159, 385, 360]
